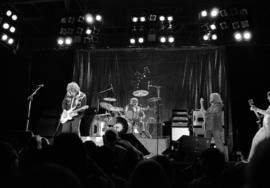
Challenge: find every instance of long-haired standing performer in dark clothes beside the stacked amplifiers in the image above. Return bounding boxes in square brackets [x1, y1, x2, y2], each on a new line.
[200, 93, 225, 154]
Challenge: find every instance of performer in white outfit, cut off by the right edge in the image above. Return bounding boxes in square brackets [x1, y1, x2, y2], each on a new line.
[248, 91, 270, 161]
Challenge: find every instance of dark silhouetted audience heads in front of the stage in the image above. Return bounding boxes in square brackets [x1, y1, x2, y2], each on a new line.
[0, 129, 270, 188]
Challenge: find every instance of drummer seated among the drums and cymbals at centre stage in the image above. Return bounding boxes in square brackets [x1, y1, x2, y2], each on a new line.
[124, 97, 151, 138]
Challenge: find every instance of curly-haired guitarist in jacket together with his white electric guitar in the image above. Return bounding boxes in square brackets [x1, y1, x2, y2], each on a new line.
[60, 82, 88, 136]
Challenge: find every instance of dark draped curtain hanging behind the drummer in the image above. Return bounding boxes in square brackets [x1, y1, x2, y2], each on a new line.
[73, 47, 232, 151]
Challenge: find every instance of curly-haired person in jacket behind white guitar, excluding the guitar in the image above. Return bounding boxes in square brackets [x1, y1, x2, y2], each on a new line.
[62, 82, 87, 137]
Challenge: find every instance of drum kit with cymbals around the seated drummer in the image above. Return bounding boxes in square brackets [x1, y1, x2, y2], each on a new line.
[92, 83, 161, 136]
